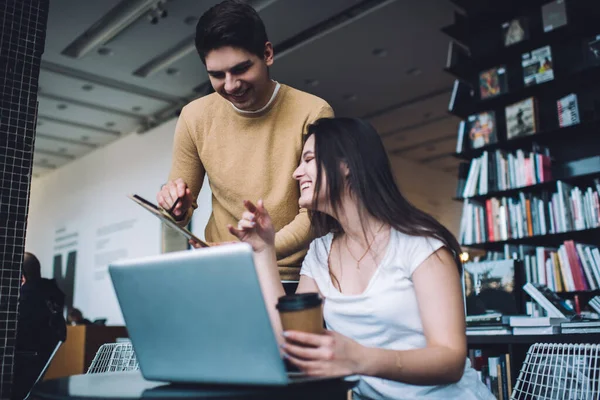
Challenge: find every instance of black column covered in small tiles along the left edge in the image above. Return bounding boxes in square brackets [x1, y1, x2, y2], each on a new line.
[0, 0, 49, 399]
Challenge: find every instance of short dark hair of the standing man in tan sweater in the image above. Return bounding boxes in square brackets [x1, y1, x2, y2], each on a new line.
[196, 0, 269, 64]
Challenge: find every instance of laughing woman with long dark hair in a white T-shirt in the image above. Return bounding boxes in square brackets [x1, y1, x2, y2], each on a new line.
[229, 118, 494, 400]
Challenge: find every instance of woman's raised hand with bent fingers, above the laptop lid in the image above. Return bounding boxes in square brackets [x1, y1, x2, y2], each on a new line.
[227, 200, 275, 253]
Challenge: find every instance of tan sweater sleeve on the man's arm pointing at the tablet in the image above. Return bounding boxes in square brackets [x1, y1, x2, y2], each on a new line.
[169, 108, 206, 226]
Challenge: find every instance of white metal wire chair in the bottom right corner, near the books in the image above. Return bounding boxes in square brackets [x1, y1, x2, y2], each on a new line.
[510, 343, 600, 400]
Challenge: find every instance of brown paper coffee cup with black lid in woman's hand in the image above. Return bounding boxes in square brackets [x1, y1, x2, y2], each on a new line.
[277, 293, 323, 333]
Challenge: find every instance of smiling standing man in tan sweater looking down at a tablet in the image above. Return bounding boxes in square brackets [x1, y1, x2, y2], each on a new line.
[157, 0, 333, 280]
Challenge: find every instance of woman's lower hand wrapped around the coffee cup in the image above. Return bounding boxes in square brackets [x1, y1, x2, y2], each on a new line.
[281, 331, 367, 376]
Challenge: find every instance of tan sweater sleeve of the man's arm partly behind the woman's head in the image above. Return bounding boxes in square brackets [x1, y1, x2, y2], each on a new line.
[275, 103, 333, 259]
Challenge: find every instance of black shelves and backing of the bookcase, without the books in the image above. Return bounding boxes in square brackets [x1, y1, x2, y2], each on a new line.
[442, 0, 600, 394]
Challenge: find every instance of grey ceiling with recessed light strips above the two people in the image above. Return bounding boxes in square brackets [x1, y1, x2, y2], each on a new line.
[34, 0, 458, 176]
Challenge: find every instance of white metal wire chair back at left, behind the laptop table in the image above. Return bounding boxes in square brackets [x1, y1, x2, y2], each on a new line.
[87, 343, 140, 374]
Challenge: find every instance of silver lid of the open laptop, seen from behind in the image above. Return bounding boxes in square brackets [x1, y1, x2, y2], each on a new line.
[108, 243, 288, 385]
